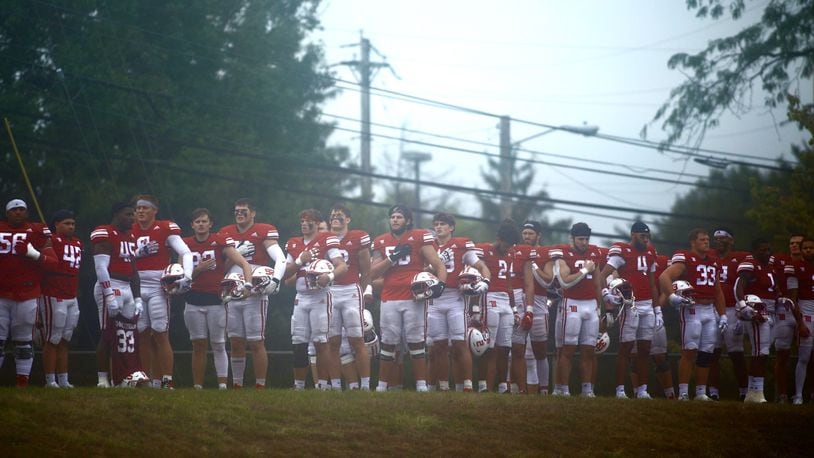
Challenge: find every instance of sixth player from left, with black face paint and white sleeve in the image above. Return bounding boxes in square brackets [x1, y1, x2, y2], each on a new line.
[219, 198, 286, 389]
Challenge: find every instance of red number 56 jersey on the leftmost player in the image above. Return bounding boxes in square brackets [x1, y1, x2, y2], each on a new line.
[0, 221, 51, 301]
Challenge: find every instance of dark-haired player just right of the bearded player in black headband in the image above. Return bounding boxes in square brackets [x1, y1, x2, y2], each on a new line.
[427, 212, 491, 392]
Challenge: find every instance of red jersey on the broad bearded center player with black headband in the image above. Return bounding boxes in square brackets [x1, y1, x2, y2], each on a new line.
[373, 229, 435, 301]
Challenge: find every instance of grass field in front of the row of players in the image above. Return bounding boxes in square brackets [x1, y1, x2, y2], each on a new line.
[0, 387, 814, 457]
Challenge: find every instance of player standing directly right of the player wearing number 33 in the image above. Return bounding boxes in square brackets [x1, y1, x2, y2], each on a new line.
[709, 227, 749, 401]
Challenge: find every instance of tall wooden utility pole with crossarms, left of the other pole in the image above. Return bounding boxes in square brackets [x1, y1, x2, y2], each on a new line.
[340, 36, 392, 200]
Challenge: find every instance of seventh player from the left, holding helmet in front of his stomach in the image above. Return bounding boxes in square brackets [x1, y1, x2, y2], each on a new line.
[285, 209, 348, 390]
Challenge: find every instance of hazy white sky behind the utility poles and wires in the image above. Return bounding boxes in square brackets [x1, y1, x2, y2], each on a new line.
[316, 0, 812, 236]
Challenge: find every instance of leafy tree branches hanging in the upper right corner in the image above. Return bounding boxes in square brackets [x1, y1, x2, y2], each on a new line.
[642, 0, 814, 145]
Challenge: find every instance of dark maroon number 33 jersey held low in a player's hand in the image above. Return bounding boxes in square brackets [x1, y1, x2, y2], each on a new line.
[103, 314, 142, 385]
